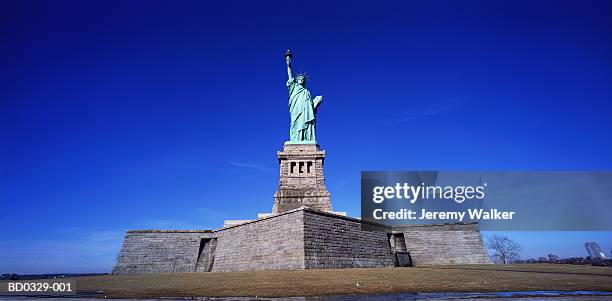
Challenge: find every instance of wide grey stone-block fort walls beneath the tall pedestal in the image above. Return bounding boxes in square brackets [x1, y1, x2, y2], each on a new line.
[113, 207, 490, 275]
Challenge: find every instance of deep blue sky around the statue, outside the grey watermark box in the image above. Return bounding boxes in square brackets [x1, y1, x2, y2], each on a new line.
[0, 0, 612, 273]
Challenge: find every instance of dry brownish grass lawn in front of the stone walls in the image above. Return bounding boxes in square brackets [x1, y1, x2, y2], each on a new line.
[65, 264, 612, 298]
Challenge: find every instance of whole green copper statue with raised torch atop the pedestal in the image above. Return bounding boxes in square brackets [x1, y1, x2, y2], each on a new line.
[285, 50, 323, 144]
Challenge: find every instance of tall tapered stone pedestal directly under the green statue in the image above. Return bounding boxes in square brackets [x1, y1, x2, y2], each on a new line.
[272, 143, 332, 214]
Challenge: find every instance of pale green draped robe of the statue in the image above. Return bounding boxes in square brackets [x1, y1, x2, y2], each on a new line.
[287, 79, 320, 142]
